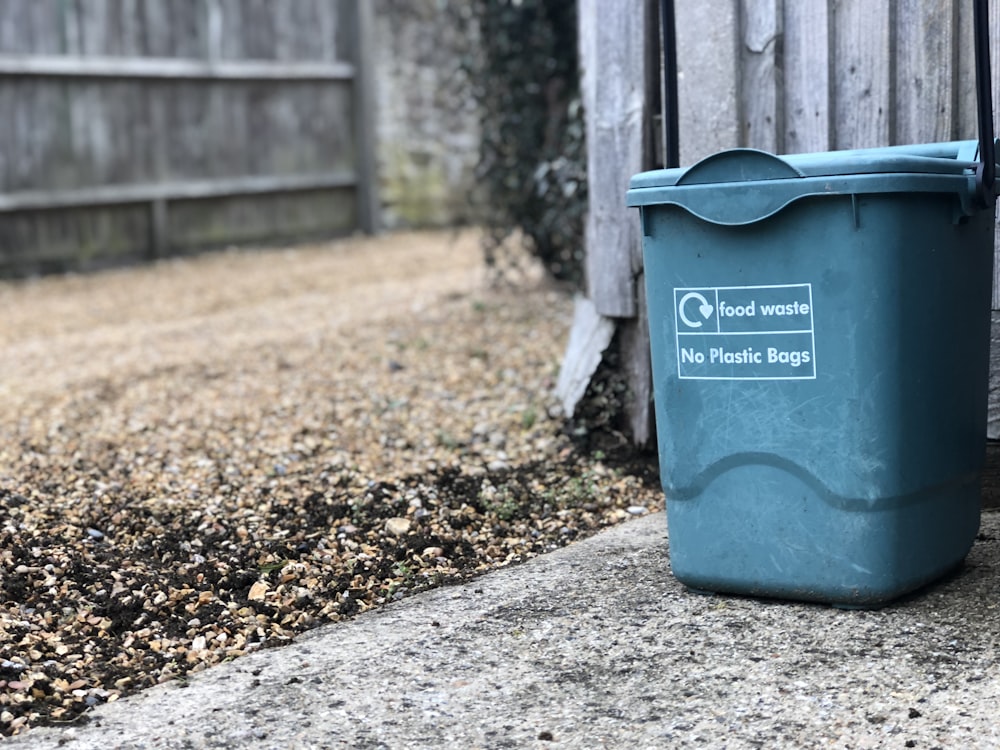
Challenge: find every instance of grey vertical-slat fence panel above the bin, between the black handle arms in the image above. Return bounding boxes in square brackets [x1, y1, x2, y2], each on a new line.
[676, 0, 984, 164]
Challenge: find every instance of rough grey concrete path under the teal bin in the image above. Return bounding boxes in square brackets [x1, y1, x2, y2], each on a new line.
[11, 513, 1000, 750]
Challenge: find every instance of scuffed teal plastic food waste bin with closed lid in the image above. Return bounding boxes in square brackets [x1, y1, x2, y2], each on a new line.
[628, 141, 994, 607]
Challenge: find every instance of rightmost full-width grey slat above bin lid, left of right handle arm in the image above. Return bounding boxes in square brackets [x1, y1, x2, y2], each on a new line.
[893, 0, 958, 144]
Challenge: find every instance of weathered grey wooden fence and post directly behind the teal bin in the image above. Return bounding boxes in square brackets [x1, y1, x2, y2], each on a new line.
[580, 0, 1000, 442]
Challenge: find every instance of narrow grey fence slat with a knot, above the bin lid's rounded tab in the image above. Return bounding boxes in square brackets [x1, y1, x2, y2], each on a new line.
[739, 0, 785, 154]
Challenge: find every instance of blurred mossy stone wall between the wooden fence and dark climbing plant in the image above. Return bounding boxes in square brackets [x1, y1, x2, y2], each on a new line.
[374, 0, 479, 229]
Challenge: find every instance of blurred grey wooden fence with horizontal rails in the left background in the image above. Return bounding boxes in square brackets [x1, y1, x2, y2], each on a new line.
[0, 0, 377, 274]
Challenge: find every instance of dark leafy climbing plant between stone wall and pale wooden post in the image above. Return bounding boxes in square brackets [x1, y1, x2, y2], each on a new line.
[452, 0, 587, 286]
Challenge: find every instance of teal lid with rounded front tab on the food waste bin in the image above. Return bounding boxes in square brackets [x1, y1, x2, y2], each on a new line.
[627, 141, 979, 225]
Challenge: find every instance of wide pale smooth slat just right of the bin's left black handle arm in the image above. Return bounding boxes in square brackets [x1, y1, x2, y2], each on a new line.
[672, 0, 740, 166]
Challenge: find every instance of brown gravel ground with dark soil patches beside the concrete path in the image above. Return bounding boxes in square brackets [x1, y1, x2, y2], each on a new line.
[0, 232, 661, 735]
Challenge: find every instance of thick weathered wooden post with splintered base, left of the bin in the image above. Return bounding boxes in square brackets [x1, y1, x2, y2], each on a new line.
[576, 0, 659, 445]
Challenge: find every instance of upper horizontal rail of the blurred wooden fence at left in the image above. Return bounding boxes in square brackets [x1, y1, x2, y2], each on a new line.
[0, 55, 355, 81]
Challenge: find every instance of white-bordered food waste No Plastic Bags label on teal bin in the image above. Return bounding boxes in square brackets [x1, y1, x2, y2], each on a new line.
[674, 284, 816, 380]
